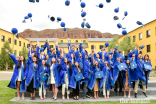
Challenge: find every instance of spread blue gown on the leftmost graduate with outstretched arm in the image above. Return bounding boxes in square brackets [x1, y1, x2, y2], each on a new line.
[7, 54, 26, 92]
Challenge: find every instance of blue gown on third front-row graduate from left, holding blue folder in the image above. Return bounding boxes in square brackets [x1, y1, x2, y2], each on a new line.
[39, 66, 49, 89]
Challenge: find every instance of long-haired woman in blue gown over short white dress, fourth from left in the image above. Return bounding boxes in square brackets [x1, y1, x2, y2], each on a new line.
[48, 57, 61, 100]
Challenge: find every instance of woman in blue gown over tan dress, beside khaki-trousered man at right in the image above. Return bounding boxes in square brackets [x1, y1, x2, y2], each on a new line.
[122, 56, 134, 98]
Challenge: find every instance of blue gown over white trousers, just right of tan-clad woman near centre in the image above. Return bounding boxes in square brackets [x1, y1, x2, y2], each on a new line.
[100, 66, 112, 90]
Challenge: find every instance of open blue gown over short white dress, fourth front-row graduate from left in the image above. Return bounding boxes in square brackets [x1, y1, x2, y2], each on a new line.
[48, 63, 61, 87]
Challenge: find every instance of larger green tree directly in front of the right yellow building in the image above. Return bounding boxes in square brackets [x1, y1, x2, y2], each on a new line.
[118, 36, 136, 52]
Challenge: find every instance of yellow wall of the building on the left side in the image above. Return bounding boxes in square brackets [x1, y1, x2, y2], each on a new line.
[0, 29, 29, 56]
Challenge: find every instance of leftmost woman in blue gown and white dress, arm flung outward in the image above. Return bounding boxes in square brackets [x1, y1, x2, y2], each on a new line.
[5, 49, 26, 100]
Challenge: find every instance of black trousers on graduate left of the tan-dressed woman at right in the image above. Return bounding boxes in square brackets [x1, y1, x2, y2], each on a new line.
[114, 71, 123, 92]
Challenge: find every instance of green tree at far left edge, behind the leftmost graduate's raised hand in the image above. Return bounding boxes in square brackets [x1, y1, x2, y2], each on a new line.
[1, 41, 14, 70]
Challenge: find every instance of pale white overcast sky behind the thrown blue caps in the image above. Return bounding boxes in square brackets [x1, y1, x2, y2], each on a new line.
[0, 0, 156, 34]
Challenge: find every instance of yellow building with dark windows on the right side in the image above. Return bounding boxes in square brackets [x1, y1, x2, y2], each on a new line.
[118, 20, 156, 69]
